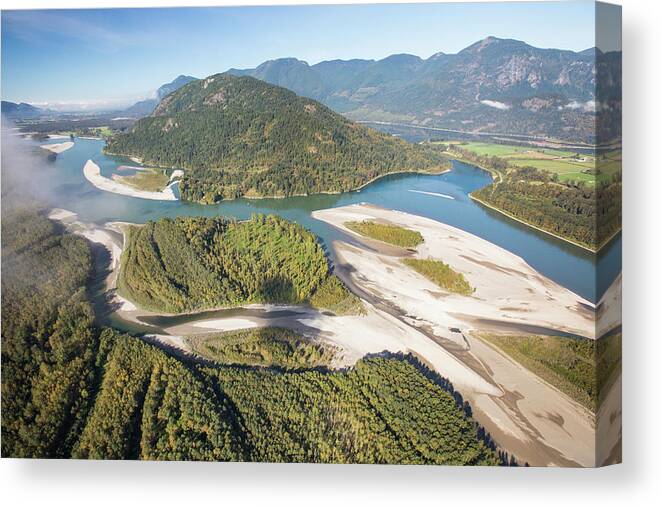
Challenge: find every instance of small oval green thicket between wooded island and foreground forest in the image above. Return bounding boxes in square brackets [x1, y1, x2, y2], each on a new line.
[187, 327, 335, 369]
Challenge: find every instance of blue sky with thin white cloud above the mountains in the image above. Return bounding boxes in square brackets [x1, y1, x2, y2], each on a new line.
[1, 1, 619, 109]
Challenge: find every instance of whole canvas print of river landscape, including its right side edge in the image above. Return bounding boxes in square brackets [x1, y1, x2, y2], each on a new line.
[1, 1, 622, 467]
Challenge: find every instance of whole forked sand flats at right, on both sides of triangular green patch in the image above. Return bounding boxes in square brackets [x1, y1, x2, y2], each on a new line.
[313, 205, 595, 466]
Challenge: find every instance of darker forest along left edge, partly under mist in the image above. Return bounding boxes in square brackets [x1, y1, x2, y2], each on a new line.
[2, 208, 97, 458]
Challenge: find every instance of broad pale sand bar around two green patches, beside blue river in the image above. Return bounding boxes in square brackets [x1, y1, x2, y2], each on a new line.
[312, 204, 595, 340]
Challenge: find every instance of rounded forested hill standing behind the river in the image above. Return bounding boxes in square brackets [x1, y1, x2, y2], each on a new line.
[107, 74, 447, 202]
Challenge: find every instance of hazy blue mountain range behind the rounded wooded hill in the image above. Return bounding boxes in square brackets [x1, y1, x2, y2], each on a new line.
[229, 37, 622, 142]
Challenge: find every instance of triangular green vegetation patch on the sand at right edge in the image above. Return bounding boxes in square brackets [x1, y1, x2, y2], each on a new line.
[479, 334, 622, 411]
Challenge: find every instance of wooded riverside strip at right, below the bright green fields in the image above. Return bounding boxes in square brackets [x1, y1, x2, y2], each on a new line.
[452, 146, 622, 251]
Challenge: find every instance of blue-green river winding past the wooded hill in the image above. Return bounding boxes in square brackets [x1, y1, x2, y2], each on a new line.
[36, 139, 622, 301]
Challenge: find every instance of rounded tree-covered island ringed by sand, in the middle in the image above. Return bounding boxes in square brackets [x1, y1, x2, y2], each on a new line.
[118, 215, 360, 313]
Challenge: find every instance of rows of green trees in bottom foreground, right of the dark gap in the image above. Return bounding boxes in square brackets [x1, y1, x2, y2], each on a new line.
[73, 332, 499, 465]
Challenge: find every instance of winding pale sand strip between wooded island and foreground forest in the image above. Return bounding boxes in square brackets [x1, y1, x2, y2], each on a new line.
[49, 209, 501, 396]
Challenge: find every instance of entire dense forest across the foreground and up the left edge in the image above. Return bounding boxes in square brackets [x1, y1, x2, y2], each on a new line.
[2, 211, 504, 465]
